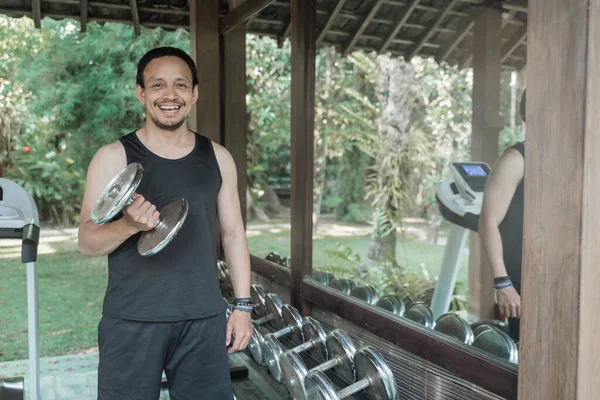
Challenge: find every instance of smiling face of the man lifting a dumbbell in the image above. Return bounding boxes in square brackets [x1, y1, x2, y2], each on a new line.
[137, 56, 198, 131]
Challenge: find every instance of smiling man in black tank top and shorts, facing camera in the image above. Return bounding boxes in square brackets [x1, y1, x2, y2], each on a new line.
[79, 48, 252, 400]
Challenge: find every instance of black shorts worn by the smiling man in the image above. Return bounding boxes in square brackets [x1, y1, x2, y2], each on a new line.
[98, 314, 233, 400]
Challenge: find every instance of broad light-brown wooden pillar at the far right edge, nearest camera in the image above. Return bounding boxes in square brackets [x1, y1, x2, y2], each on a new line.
[519, 0, 600, 400]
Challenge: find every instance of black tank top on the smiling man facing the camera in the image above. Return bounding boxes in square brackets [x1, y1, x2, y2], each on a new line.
[103, 132, 225, 321]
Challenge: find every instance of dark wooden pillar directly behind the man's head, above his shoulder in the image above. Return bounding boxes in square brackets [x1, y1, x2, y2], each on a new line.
[190, 0, 222, 143]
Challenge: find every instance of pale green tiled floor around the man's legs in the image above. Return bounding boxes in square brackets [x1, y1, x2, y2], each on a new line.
[0, 353, 287, 400]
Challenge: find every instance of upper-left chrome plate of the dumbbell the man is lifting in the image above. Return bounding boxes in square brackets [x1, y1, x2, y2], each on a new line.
[92, 163, 144, 225]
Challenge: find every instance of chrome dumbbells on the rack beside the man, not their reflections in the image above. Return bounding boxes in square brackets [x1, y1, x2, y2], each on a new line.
[225, 284, 397, 400]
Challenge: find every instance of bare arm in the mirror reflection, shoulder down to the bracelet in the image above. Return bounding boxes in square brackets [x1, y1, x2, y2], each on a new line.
[478, 149, 524, 277]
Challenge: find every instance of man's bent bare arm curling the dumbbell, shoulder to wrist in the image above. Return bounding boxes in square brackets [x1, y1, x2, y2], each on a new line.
[78, 142, 135, 257]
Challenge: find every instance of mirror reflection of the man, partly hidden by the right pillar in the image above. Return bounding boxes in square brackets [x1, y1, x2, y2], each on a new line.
[478, 92, 525, 342]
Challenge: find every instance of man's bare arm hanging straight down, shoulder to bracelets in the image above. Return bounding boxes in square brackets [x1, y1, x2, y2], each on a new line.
[213, 143, 251, 298]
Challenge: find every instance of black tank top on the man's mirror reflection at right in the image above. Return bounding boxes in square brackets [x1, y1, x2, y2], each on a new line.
[499, 142, 525, 284]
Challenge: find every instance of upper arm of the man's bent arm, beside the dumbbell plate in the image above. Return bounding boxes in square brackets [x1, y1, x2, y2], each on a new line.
[80, 142, 127, 225]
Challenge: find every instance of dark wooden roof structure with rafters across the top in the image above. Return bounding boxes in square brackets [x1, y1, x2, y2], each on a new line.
[0, 0, 527, 70]
